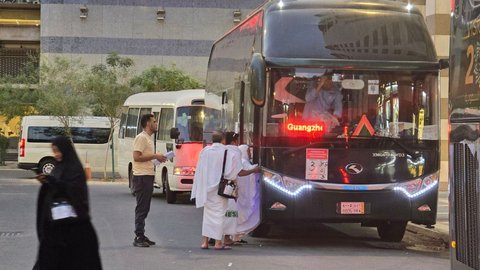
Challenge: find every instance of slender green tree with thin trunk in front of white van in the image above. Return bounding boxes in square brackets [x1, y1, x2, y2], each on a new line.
[85, 53, 134, 178]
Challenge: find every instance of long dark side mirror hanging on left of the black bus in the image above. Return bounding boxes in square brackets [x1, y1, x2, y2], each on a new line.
[249, 53, 267, 107]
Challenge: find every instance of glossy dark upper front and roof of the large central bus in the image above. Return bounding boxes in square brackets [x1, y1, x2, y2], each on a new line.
[214, 0, 438, 65]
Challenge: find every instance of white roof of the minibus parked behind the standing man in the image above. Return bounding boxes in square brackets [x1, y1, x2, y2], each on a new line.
[123, 89, 205, 106]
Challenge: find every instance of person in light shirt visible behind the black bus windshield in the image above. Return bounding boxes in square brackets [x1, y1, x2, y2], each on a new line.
[302, 72, 343, 130]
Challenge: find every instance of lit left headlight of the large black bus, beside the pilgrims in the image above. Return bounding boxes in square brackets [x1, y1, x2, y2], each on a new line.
[263, 171, 312, 196]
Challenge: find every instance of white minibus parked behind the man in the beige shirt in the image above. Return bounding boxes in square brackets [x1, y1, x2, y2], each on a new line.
[117, 89, 218, 203]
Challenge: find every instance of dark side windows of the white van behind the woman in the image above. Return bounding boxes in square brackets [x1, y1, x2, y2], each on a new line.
[27, 127, 110, 144]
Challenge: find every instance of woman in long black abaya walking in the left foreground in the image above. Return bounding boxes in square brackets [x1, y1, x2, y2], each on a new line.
[33, 136, 102, 270]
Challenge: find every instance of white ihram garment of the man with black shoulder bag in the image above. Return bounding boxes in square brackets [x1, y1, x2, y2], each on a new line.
[191, 143, 242, 240]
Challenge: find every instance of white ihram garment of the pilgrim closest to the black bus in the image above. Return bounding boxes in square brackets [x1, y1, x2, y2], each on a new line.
[236, 145, 260, 234]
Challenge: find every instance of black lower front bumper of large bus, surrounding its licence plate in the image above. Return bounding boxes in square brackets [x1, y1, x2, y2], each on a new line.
[262, 181, 438, 226]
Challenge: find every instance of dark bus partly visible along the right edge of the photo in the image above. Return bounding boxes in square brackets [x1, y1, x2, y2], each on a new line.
[449, 0, 480, 270]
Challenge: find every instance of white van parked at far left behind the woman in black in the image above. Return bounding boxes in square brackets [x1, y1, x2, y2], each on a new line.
[18, 115, 111, 174]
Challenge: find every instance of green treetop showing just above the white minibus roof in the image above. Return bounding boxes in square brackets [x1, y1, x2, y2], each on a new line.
[130, 66, 203, 92]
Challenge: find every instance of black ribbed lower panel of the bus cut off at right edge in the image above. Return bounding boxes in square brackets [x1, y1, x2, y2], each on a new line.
[451, 143, 480, 269]
